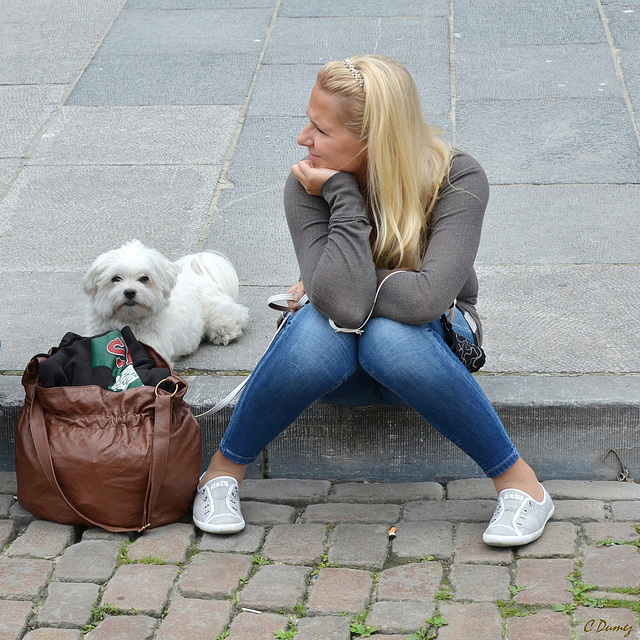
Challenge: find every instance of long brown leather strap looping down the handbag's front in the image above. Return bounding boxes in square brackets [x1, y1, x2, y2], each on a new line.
[28, 378, 177, 533]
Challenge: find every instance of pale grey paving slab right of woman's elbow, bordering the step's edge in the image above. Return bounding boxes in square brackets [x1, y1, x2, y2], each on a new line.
[478, 265, 639, 376]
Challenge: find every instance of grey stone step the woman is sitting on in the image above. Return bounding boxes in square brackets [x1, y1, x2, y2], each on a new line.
[0, 374, 640, 482]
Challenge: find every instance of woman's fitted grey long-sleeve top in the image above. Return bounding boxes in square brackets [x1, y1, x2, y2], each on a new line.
[284, 151, 489, 344]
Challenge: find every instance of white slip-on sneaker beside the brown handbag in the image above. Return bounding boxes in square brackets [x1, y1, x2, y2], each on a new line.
[193, 476, 244, 533]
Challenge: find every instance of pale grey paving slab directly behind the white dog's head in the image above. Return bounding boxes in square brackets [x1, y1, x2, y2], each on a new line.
[0, 166, 217, 270]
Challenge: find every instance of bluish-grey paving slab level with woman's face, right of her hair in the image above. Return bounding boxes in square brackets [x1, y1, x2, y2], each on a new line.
[456, 98, 640, 184]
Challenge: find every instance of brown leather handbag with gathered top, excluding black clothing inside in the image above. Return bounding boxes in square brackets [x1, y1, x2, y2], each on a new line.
[16, 334, 201, 531]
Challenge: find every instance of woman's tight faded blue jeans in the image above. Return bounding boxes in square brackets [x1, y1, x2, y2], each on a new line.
[220, 304, 519, 478]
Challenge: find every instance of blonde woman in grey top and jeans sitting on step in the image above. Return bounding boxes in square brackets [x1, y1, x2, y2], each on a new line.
[194, 55, 553, 546]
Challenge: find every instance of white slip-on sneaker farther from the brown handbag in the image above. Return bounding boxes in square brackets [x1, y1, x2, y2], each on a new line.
[482, 485, 555, 547]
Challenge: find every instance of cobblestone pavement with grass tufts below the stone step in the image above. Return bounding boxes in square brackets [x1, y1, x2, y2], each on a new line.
[0, 473, 640, 640]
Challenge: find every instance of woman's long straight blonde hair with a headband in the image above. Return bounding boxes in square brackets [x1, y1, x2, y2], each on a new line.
[316, 55, 452, 269]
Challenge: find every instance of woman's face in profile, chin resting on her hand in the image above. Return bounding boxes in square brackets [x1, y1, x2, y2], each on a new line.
[297, 85, 367, 174]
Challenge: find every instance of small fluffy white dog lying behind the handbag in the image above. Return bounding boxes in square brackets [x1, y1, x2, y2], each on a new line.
[84, 240, 249, 361]
